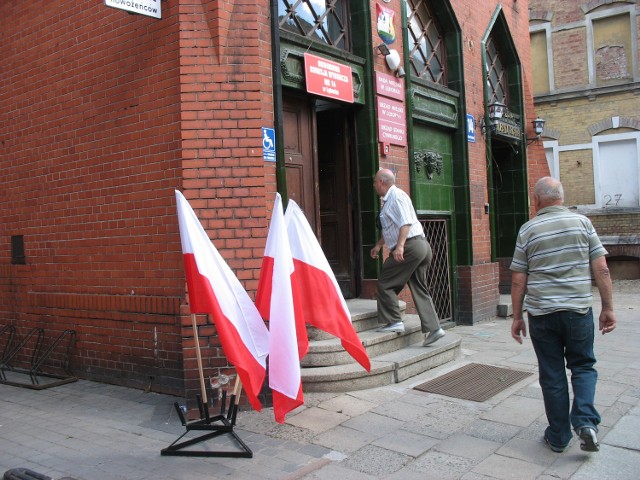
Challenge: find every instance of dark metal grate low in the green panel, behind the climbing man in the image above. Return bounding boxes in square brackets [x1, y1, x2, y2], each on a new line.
[420, 219, 453, 322]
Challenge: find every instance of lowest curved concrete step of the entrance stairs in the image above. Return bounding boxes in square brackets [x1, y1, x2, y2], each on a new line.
[302, 332, 462, 393]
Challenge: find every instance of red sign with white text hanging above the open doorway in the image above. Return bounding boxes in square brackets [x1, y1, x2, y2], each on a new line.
[304, 53, 353, 103]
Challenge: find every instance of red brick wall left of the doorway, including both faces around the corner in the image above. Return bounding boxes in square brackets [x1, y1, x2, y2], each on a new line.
[0, 0, 276, 404]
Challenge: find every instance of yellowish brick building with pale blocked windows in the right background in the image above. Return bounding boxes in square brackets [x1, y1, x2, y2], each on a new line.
[529, 0, 640, 278]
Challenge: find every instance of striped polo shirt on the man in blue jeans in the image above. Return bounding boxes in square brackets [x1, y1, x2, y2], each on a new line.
[510, 206, 607, 315]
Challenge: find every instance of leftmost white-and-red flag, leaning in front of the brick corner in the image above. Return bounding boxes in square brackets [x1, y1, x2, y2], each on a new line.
[176, 190, 269, 411]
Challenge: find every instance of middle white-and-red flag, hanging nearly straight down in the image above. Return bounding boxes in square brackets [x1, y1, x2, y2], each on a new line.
[256, 193, 308, 423]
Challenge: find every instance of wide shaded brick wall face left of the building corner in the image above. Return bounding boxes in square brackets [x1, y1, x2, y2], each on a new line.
[0, 0, 184, 392]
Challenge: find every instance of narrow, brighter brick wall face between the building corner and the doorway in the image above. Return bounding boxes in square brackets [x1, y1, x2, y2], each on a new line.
[179, 0, 276, 404]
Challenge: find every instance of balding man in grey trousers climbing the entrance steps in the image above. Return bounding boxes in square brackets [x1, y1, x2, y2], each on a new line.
[370, 169, 444, 347]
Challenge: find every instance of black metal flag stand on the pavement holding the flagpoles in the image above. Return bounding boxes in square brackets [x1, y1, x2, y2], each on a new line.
[160, 391, 253, 458]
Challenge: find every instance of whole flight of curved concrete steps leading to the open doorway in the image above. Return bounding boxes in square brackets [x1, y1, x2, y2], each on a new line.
[302, 299, 461, 393]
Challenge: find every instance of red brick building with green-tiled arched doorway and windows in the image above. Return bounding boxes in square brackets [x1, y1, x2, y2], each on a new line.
[0, 0, 548, 402]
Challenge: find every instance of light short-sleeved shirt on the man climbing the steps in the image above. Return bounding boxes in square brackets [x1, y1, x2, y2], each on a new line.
[380, 185, 424, 250]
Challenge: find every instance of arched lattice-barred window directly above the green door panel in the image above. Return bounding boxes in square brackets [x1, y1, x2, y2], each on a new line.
[407, 0, 447, 86]
